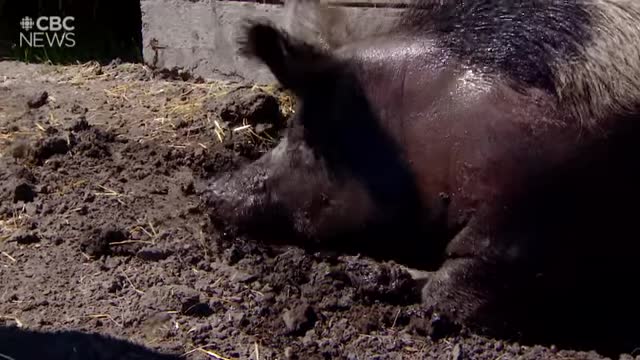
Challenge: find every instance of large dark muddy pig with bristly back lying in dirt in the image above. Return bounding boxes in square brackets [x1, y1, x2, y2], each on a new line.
[205, 0, 640, 348]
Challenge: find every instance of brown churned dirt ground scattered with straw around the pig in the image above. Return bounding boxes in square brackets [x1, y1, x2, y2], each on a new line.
[0, 62, 640, 360]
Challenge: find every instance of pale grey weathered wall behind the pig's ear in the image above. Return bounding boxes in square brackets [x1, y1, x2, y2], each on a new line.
[141, 0, 397, 83]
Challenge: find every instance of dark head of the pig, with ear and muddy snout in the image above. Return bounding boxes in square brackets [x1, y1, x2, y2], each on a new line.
[206, 22, 430, 258]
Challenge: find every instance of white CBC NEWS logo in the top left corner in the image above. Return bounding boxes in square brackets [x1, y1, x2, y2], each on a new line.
[20, 16, 76, 48]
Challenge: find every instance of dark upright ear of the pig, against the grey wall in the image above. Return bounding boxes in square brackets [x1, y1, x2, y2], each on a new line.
[238, 20, 336, 92]
